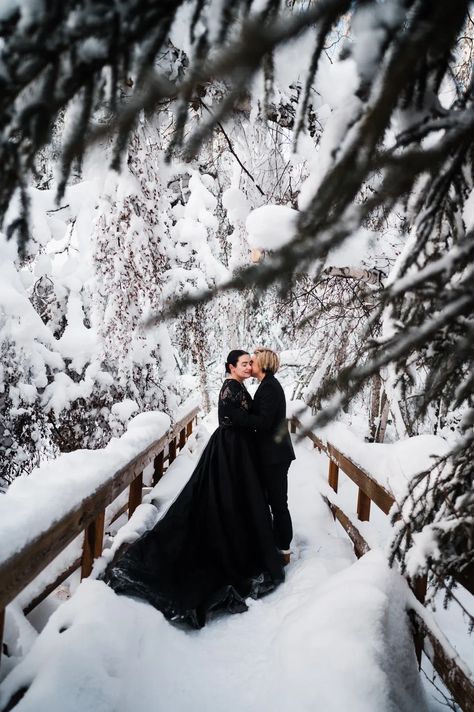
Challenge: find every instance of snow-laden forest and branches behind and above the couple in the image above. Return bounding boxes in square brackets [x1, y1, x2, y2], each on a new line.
[0, 0, 474, 660]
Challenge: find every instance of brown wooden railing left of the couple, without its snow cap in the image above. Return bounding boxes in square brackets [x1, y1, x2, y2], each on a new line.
[0, 408, 199, 672]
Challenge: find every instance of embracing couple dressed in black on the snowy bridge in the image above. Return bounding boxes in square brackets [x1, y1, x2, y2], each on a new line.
[104, 348, 295, 628]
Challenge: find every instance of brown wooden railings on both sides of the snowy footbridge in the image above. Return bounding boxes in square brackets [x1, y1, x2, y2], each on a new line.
[0, 409, 474, 712]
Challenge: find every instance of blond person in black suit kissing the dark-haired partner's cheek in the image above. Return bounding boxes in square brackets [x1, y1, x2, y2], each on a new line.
[232, 348, 295, 566]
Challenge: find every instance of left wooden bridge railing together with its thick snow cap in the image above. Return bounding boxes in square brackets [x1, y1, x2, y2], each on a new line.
[0, 408, 199, 672]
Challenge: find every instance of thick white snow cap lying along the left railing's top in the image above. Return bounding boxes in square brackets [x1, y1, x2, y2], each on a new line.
[0, 412, 170, 563]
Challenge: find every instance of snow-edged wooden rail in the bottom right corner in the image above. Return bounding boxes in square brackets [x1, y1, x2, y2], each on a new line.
[409, 610, 474, 712]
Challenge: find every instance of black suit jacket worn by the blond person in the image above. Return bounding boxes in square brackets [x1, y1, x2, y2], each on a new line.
[232, 374, 295, 464]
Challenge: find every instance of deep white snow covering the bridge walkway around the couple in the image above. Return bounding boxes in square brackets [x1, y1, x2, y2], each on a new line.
[0, 420, 466, 712]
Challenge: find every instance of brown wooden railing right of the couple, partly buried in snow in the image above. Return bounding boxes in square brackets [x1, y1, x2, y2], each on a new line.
[290, 417, 474, 712]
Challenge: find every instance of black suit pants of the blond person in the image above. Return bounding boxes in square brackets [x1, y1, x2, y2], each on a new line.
[261, 461, 293, 551]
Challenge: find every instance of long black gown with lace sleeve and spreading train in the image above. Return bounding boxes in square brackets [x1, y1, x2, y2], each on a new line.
[104, 379, 284, 628]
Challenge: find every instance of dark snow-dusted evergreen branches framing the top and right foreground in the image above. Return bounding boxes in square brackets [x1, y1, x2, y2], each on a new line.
[0, 0, 474, 596]
